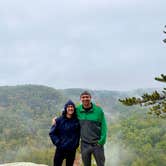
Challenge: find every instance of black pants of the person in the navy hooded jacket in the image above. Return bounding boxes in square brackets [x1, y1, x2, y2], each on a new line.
[54, 148, 76, 166]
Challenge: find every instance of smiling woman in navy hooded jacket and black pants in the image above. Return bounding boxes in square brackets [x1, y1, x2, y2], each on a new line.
[49, 100, 80, 166]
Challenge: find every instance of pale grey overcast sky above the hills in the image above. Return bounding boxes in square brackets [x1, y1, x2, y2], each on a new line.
[0, 0, 166, 90]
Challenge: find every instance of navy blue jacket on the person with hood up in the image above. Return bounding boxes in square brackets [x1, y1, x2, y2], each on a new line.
[49, 115, 80, 150]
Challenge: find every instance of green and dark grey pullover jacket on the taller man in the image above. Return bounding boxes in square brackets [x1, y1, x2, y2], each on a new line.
[77, 103, 107, 145]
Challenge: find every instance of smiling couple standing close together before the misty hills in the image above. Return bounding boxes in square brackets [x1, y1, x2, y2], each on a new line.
[49, 91, 107, 166]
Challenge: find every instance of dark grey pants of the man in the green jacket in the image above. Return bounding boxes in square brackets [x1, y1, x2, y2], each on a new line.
[81, 142, 105, 166]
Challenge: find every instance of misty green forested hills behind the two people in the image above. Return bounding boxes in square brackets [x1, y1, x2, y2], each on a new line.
[0, 85, 166, 166]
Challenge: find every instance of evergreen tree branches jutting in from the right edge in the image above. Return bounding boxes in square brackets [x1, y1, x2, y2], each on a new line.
[119, 74, 166, 118]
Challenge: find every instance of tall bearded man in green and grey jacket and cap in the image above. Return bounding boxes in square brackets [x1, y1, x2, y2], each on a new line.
[77, 91, 107, 166]
